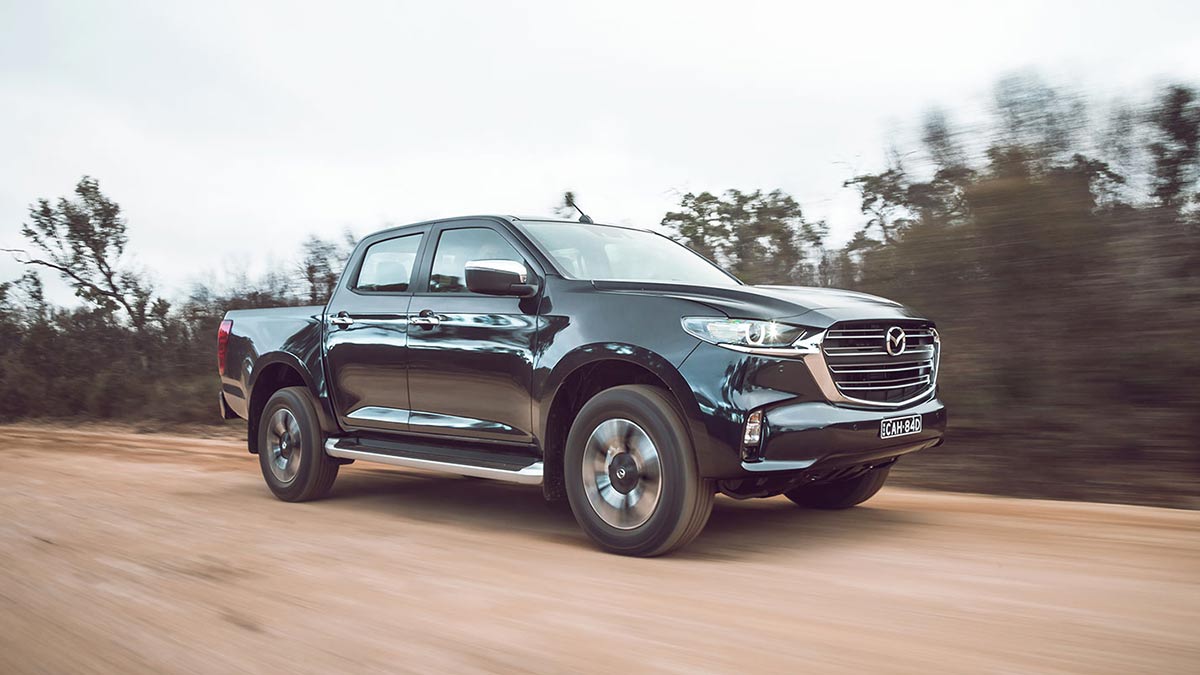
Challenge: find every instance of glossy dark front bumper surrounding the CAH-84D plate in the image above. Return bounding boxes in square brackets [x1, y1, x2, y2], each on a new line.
[742, 398, 947, 473]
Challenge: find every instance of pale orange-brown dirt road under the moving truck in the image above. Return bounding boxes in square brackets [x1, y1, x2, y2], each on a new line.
[0, 426, 1200, 673]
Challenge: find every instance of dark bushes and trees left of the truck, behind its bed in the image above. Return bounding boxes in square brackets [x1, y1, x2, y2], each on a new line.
[0, 177, 355, 422]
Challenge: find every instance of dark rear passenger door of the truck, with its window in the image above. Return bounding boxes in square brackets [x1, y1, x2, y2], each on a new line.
[325, 227, 428, 431]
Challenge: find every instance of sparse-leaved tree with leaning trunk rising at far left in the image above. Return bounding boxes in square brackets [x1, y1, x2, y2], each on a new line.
[8, 175, 169, 331]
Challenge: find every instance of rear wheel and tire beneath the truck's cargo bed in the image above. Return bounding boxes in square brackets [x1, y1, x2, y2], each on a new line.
[258, 387, 338, 502]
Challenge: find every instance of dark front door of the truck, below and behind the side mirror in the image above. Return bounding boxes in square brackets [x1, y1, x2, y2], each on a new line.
[408, 221, 538, 443]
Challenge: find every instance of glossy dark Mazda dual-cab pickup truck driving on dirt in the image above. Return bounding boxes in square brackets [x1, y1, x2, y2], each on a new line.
[217, 216, 947, 556]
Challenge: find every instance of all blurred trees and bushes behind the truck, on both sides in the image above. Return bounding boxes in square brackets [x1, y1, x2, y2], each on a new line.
[0, 76, 1200, 507]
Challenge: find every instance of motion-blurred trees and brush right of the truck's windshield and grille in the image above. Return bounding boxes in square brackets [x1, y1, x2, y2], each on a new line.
[662, 77, 1200, 507]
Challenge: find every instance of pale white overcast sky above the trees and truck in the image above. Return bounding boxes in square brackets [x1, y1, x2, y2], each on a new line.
[0, 0, 1200, 299]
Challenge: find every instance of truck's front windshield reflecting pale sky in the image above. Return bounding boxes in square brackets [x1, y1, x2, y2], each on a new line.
[520, 221, 739, 286]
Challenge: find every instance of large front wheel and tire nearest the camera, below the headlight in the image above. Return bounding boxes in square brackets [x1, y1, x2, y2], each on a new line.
[563, 384, 715, 556]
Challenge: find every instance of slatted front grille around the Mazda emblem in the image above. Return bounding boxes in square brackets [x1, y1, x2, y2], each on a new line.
[821, 321, 938, 405]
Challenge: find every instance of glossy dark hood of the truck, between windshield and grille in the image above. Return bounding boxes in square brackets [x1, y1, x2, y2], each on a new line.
[593, 281, 922, 328]
